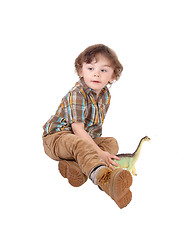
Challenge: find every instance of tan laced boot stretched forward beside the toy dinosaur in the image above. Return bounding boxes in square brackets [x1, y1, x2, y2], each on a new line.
[97, 167, 132, 208]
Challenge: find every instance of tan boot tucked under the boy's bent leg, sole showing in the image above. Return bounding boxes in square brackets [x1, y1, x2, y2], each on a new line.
[58, 160, 87, 187]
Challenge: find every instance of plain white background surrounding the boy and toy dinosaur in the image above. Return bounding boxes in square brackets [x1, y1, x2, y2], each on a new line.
[0, 0, 184, 240]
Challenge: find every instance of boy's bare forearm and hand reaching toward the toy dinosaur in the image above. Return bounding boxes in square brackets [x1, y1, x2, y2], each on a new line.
[71, 122, 119, 169]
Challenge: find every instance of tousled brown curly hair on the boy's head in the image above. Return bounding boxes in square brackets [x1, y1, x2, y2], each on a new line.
[75, 44, 123, 80]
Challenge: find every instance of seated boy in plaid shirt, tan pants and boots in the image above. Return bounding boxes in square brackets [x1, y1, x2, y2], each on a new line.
[43, 44, 132, 208]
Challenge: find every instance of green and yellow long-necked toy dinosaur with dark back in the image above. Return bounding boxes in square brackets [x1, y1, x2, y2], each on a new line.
[113, 136, 151, 176]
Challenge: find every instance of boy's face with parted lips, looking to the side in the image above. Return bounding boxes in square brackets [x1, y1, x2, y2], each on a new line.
[79, 54, 114, 95]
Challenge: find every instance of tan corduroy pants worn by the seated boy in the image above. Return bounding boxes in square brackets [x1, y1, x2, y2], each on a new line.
[43, 131, 119, 176]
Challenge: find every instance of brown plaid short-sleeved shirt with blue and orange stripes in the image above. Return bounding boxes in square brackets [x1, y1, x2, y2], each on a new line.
[43, 79, 111, 138]
